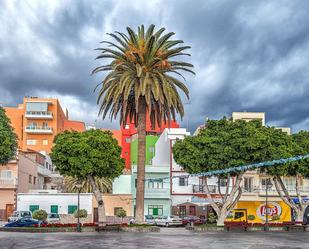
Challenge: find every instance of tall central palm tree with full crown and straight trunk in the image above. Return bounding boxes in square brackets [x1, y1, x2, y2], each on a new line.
[92, 25, 194, 223]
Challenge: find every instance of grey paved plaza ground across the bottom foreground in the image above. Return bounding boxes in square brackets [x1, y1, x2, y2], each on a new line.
[0, 228, 309, 249]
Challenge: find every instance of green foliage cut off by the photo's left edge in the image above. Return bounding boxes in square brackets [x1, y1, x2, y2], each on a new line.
[0, 107, 17, 165]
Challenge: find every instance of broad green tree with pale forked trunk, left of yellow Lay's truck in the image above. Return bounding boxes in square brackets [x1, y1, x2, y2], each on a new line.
[173, 118, 299, 225]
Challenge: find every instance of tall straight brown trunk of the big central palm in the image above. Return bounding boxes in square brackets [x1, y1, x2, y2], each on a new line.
[136, 97, 146, 224]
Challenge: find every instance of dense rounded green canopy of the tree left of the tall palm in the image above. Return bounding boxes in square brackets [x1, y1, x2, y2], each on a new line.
[51, 130, 124, 179]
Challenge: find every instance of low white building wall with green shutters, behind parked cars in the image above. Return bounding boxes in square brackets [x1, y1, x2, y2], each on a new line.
[17, 193, 92, 214]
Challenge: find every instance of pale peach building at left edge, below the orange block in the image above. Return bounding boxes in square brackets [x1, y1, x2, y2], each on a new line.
[0, 151, 60, 220]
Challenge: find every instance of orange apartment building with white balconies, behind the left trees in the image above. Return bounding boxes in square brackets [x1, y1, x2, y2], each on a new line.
[4, 97, 85, 153]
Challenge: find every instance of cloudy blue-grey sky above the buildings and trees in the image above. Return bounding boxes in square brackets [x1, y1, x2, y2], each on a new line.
[0, 0, 309, 132]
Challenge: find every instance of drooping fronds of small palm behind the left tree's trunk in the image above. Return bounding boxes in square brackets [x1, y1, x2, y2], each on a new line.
[63, 176, 113, 193]
